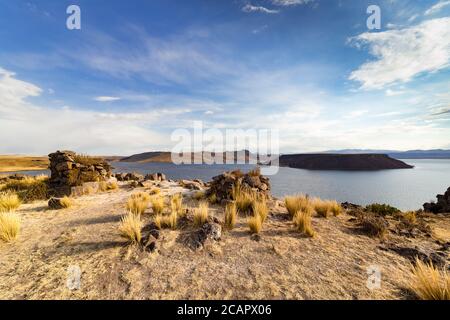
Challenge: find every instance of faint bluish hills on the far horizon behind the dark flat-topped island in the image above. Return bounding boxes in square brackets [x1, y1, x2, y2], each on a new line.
[325, 149, 450, 159]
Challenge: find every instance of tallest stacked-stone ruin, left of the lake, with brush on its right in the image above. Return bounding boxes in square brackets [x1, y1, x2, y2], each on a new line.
[48, 151, 111, 196]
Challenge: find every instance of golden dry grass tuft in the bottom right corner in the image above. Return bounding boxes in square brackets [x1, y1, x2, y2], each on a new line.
[410, 259, 450, 300]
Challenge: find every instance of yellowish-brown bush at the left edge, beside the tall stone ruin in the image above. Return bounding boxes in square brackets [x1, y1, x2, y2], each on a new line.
[2, 175, 49, 202]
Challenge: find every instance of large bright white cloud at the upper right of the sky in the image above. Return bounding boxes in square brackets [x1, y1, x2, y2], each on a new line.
[349, 18, 450, 89]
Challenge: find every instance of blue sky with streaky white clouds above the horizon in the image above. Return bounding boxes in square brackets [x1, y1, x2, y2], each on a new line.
[0, 0, 450, 155]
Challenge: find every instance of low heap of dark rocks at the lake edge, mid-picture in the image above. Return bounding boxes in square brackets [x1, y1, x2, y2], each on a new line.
[206, 170, 270, 201]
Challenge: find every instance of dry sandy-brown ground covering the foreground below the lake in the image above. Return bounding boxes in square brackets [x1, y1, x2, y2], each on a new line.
[0, 182, 450, 299]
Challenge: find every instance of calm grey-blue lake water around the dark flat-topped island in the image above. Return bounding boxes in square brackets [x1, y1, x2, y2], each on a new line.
[5, 159, 450, 210]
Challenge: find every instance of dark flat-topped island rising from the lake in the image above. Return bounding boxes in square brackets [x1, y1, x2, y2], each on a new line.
[279, 153, 413, 171]
